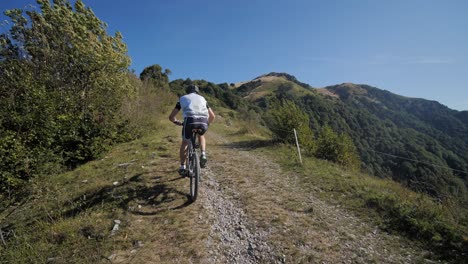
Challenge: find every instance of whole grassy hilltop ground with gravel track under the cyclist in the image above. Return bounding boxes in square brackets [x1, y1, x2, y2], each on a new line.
[0, 124, 446, 263]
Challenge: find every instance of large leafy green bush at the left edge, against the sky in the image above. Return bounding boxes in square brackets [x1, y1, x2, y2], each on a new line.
[0, 0, 135, 193]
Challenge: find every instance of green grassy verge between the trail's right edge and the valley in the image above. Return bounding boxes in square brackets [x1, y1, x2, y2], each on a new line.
[266, 146, 468, 261]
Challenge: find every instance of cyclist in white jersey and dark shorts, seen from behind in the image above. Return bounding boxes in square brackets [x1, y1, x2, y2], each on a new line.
[169, 85, 215, 176]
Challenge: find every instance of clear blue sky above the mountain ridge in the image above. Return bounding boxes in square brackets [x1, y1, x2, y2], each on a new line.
[0, 0, 468, 110]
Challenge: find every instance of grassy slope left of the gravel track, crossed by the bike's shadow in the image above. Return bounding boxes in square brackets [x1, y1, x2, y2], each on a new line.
[0, 121, 209, 263]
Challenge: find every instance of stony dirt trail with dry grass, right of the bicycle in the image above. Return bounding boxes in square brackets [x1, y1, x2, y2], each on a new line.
[197, 132, 430, 263]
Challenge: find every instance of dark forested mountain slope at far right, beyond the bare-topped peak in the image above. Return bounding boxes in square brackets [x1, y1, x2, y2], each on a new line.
[324, 84, 468, 202]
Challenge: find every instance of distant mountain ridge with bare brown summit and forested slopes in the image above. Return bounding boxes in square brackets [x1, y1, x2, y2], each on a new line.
[233, 73, 468, 198]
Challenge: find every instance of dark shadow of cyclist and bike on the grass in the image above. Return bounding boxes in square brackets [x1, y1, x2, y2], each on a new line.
[63, 173, 192, 218]
